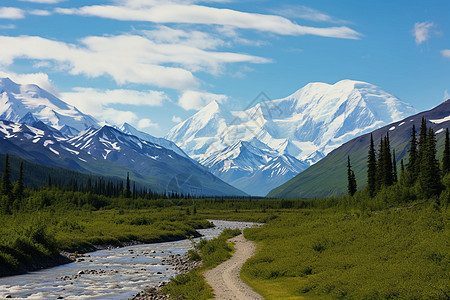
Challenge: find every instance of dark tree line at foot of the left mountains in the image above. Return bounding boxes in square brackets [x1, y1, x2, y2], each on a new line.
[0, 154, 199, 214]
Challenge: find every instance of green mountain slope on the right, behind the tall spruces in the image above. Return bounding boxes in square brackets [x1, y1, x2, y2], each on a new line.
[267, 100, 450, 198]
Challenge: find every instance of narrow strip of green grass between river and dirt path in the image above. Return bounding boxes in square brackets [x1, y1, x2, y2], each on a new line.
[162, 229, 240, 300]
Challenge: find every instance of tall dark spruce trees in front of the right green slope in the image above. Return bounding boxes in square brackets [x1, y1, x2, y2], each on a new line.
[347, 118, 450, 198]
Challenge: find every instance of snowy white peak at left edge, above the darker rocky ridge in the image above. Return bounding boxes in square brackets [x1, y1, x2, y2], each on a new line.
[0, 78, 99, 135]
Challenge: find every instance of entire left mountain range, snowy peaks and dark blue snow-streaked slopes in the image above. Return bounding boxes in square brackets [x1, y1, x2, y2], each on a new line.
[0, 78, 246, 196]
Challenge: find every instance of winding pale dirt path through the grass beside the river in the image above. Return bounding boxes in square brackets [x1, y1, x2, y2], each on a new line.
[204, 234, 264, 300]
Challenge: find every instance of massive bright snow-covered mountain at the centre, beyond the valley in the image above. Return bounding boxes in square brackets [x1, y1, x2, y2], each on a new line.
[166, 80, 416, 195]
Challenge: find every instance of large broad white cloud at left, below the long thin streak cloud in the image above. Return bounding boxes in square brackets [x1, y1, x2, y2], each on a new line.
[0, 35, 270, 89]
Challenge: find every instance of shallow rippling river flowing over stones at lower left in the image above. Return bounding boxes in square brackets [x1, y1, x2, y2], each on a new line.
[0, 220, 256, 299]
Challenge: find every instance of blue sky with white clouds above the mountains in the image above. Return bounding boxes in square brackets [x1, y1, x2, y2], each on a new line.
[0, 0, 450, 136]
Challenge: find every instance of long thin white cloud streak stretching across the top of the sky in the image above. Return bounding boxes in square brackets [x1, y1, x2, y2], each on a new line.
[56, 1, 361, 39]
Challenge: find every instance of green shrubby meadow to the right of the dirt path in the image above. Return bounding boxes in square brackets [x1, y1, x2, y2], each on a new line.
[242, 203, 450, 299]
